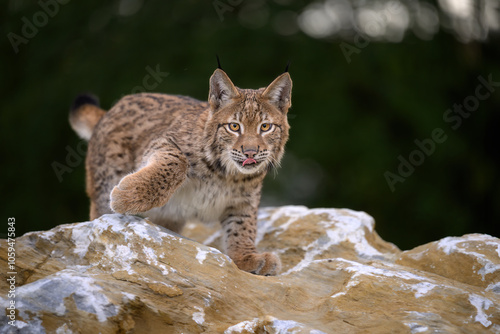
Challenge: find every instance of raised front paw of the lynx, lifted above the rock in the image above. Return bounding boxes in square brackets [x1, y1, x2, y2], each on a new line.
[110, 172, 169, 214]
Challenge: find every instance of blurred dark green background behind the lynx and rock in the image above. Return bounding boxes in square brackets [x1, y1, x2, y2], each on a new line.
[0, 0, 500, 249]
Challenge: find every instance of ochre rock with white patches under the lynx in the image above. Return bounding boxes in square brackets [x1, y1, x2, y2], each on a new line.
[0, 206, 500, 333]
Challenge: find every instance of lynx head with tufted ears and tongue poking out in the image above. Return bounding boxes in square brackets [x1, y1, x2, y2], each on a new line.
[205, 68, 292, 174]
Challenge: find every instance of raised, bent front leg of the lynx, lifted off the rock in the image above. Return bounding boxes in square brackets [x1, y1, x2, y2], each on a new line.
[110, 139, 188, 214]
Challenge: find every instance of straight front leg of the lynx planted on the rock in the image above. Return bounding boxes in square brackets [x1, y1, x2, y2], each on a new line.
[222, 210, 281, 276]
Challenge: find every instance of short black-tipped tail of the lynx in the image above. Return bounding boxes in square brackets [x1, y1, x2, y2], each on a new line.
[69, 93, 106, 140]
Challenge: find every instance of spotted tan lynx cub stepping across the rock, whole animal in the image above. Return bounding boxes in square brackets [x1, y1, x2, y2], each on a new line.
[70, 68, 292, 275]
